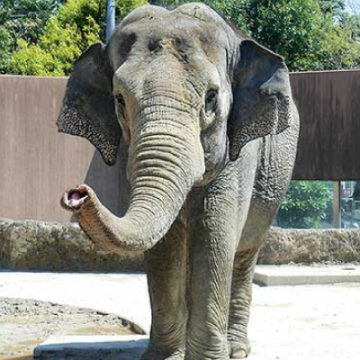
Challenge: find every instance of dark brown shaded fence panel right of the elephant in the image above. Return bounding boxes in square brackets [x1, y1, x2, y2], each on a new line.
[291, 70, 360, 180]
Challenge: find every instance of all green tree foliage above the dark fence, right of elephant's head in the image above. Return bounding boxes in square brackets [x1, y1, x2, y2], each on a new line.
[242, 0, 360, 71]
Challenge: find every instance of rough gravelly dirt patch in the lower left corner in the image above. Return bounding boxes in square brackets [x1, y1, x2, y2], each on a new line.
[0, 298, 137, 360]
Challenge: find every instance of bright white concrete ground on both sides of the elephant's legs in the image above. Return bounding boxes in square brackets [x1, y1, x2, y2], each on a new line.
[0, 272, 360, 360]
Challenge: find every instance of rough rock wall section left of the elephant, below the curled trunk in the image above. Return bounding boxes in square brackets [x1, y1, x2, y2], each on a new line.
[0, 219, 143, 271]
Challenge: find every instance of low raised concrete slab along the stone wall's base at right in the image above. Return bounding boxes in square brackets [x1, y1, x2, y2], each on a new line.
[254, 264, 360, 286]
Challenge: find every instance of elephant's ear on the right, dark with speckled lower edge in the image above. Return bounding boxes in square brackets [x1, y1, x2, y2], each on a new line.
[228, 40, 291, 160]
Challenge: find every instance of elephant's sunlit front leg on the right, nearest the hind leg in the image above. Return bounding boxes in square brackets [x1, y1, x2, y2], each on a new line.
[186, 187, 242, 360]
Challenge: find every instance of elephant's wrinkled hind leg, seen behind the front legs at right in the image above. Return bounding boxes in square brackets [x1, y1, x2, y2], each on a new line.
[228, 248, 259, 359]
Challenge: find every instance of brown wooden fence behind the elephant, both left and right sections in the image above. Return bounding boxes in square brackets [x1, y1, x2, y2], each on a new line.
[0, 71, 360, 222]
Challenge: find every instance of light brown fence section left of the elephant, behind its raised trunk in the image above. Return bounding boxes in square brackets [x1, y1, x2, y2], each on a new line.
[0, 76, 129, 222]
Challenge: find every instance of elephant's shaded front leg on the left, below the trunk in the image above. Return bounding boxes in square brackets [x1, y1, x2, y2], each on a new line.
[142, 219, 187, 360]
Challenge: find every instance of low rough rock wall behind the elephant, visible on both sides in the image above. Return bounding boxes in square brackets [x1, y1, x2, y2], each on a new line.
[0, 219, 360, 272]
